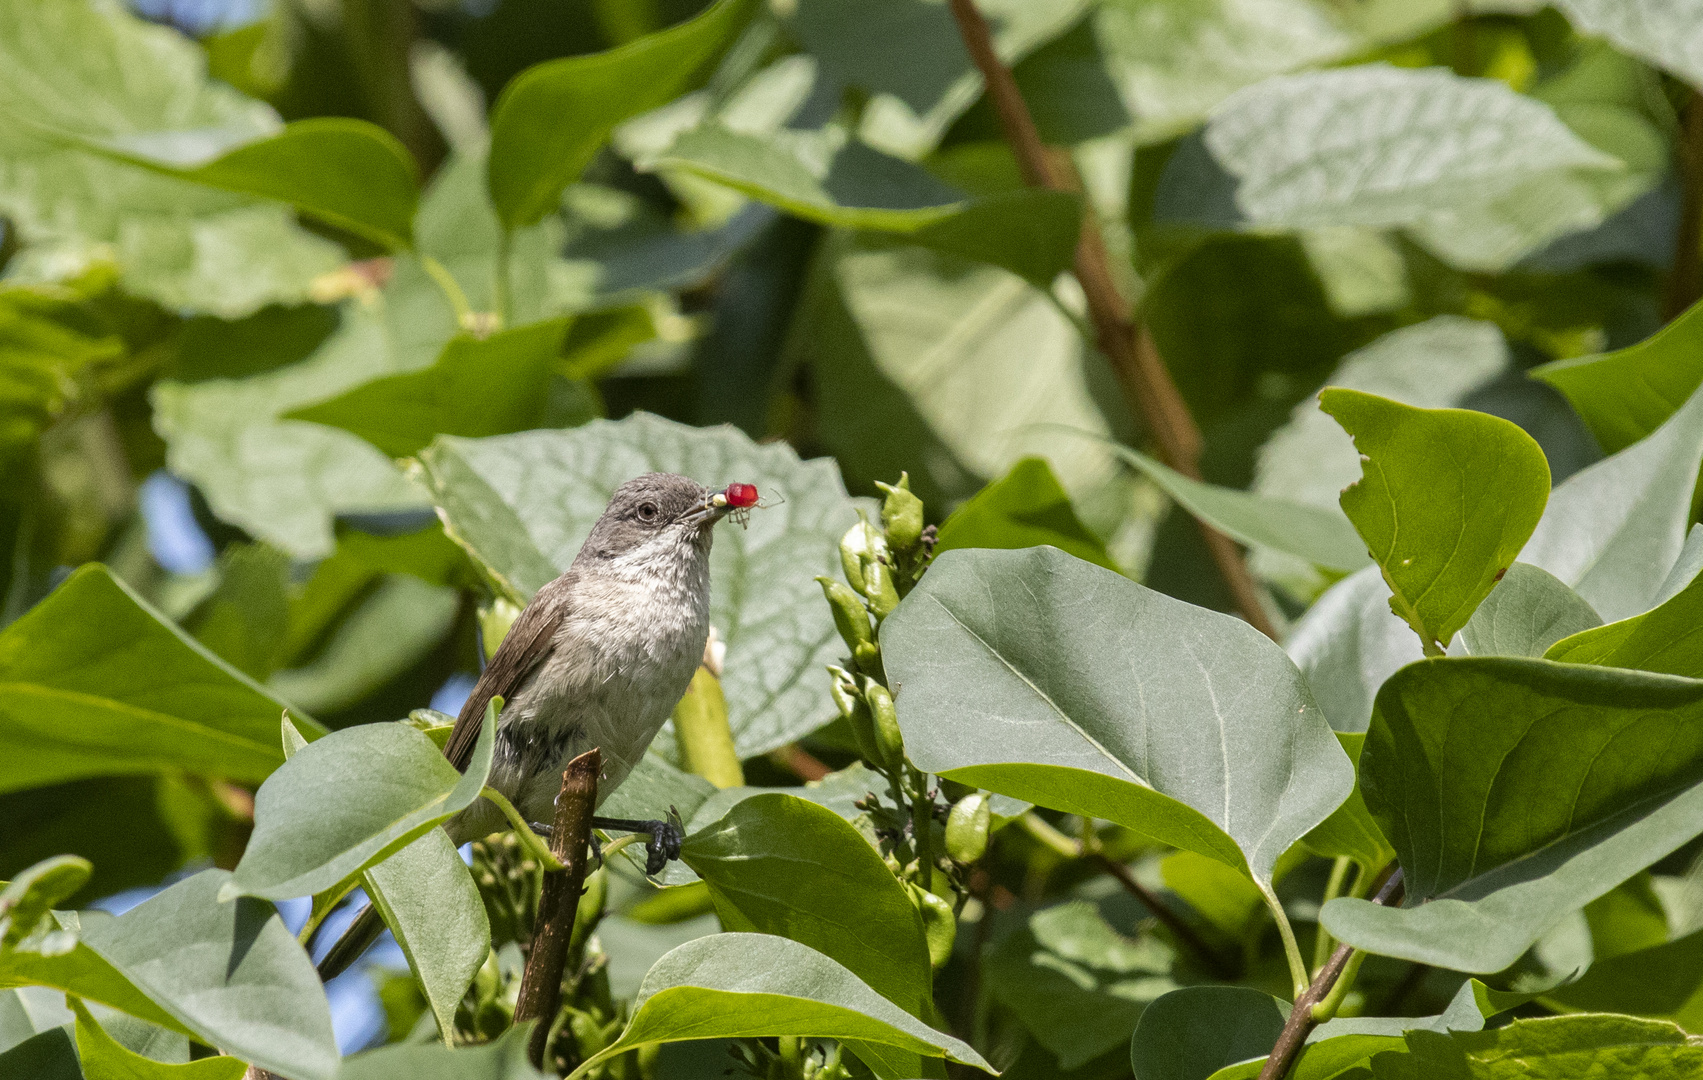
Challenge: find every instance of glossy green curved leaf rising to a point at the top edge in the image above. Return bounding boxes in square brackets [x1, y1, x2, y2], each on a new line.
[485, 0, 749, 230]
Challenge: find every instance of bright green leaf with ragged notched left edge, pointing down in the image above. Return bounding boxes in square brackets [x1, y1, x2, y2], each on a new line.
[1318, 387, 1550, 652]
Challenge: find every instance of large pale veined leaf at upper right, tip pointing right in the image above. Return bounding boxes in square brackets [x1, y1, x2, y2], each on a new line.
[1175, 65, 1655, 271]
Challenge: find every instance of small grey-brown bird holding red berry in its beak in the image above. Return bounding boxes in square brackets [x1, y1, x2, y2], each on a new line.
[320, 472, 742, 978]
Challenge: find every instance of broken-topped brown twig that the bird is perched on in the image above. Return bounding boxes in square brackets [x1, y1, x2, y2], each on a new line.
[514, 748, 603, 1068]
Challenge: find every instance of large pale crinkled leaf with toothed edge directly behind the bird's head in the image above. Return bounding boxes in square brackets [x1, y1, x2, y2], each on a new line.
[421, 414, 857, 756]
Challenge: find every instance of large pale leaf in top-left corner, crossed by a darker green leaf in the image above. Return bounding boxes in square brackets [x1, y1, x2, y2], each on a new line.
[0, 0, 342, 317]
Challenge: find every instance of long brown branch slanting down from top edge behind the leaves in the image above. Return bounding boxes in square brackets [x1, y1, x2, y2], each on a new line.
[950, 0, 1277, 641]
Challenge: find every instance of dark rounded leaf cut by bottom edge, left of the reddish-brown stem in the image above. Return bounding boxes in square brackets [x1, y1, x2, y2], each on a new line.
[1129, 986, 1289, 1080]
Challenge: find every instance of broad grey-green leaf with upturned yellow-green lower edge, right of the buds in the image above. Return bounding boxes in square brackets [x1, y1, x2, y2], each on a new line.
[882, 547, 1354, 889]
